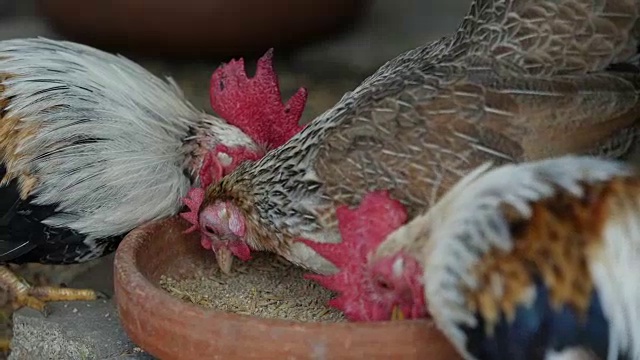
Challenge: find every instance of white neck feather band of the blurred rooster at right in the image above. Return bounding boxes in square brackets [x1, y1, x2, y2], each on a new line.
[412, 156, 640, 358]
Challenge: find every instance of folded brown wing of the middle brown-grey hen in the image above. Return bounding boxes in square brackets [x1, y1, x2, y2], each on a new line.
[315, 70, 640, 216]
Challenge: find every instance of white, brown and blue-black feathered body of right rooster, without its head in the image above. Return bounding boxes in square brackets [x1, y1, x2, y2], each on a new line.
[424, 157, 640, 360]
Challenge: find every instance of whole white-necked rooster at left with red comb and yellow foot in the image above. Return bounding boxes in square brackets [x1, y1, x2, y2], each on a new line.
[0, 39, 307, 310]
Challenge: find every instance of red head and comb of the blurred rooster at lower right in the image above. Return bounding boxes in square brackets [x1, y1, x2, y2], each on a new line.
[305, 191, 428, 321]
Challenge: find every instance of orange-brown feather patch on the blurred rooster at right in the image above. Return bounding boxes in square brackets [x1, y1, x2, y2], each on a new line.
[466, 177, 640, 332]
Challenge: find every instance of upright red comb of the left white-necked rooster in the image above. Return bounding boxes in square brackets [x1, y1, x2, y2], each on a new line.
[210, 49, 307, 149]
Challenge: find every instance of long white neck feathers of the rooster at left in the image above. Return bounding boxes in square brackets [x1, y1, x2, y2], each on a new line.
[0, 38, 254, 246]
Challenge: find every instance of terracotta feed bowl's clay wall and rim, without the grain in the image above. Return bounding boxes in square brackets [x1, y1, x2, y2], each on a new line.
[114, 218, 459, 360]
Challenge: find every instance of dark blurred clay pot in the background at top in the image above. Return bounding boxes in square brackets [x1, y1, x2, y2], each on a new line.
[38, 0, 371, 57]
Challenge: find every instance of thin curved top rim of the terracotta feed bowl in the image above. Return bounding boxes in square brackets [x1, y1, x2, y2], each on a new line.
[114, 217, 435, 331]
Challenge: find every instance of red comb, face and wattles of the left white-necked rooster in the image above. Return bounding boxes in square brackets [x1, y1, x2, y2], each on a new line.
[180, 49, 307, 248]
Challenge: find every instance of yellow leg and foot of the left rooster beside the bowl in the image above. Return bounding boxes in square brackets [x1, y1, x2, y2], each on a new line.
[0, 266, 104, 316]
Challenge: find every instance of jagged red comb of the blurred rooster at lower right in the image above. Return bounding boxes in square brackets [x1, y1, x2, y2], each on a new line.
[299, 191, 407, 320]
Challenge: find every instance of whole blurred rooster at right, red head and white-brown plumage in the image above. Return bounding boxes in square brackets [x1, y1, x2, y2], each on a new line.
[312, 156, 640, 360]
